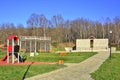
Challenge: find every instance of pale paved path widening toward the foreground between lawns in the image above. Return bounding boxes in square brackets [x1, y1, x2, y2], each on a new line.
[25, 52, 109, 80]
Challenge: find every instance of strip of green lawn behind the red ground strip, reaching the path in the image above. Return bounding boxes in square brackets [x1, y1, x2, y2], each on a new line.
[27, 52, 96, 63]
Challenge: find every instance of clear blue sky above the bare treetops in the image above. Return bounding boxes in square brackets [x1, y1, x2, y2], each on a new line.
[0, 0, 120, 26]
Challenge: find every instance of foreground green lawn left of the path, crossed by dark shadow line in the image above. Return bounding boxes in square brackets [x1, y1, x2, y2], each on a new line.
[0, 64, 65, 80]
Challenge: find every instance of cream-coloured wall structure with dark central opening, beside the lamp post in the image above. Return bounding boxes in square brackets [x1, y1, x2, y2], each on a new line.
[74, 37, 109, 52]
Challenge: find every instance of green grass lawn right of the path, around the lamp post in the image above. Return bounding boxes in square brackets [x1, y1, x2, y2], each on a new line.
[91, 54, 120, 80]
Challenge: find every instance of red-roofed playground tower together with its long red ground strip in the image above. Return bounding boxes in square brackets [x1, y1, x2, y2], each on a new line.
[0, 35, 56, 65]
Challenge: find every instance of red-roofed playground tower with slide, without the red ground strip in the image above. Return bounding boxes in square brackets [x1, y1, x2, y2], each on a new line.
[0, 35, 25, 64]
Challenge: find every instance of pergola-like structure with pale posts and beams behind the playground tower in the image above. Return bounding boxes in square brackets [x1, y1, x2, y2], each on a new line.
[20, 36, 51, 53]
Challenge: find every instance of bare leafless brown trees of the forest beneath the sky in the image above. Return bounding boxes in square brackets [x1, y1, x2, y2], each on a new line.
[0, 13, 120, 45]
